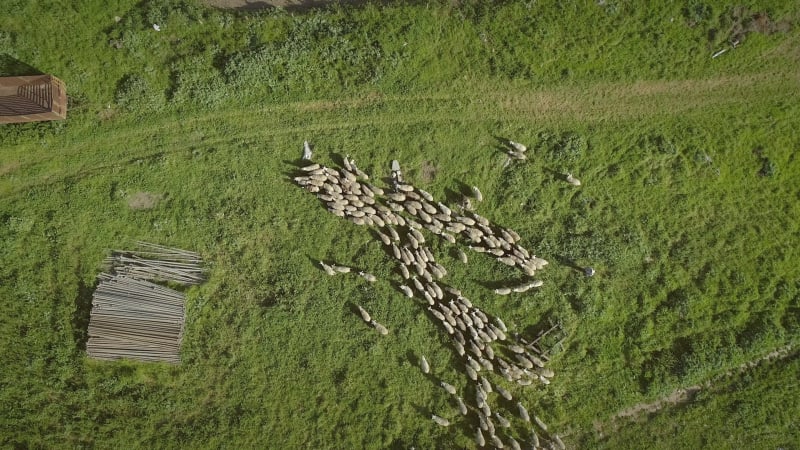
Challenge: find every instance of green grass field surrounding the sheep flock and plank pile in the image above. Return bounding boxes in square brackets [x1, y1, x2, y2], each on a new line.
[0, 0, 800, 449]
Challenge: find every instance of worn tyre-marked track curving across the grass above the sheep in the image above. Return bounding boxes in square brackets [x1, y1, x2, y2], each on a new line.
[0, 73, 800, 198]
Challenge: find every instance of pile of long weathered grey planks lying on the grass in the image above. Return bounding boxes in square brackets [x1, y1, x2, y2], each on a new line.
[86, 242, 203, 364]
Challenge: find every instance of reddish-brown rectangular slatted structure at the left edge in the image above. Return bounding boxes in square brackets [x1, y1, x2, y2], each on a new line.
[0, 75, 67, 124]
